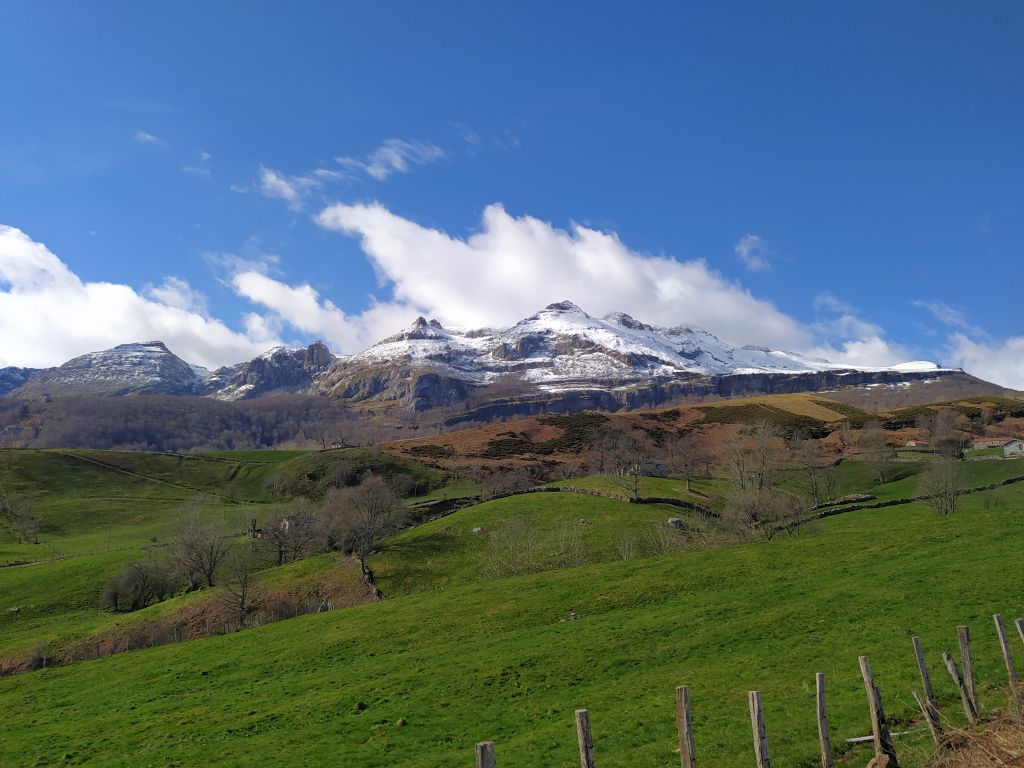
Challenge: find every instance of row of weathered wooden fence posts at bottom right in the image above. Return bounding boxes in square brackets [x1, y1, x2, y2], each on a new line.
[476, 613, 1024, 768]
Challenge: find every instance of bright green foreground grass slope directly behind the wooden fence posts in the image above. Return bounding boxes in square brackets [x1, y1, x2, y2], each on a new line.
[0, 485, 1024, 768]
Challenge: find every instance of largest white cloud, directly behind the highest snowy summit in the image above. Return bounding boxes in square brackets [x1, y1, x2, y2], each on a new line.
[317, 204, 811, 348]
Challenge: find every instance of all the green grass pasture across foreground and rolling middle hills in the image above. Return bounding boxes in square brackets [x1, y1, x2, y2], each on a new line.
[0, 452, 1024, 768]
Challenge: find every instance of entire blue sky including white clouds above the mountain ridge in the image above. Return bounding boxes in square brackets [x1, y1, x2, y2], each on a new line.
[0, 2, 1024, 387]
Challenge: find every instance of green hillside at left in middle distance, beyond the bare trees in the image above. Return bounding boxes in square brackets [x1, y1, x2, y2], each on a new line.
[0, 449, 438, 658]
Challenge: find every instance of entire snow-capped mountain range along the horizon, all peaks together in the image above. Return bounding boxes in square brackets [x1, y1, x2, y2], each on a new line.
[0, 301, 956, 418]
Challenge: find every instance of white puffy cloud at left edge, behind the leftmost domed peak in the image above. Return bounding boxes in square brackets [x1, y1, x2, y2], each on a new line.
[0, 224, 278, 368]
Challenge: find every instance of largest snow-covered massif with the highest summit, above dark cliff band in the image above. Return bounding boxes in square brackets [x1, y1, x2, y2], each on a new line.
[317, 301, 939, 410]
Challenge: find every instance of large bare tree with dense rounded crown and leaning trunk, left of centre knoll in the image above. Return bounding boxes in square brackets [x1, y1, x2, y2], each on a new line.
[324, 475, 406, 577]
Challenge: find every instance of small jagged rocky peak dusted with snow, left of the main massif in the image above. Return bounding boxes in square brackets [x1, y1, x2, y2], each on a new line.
[203, 341, 335, 400]
